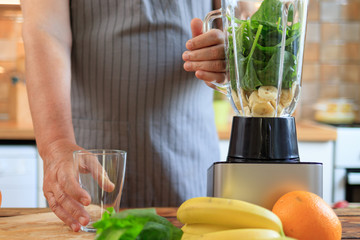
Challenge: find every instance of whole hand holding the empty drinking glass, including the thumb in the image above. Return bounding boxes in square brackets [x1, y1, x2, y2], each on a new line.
[43, 141, 115, 231]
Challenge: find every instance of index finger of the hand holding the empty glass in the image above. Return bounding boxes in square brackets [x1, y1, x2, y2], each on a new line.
[57, 171, 91, 206]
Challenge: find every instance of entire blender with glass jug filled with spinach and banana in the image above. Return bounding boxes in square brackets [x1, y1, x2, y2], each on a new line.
[204, 0, 322, 209]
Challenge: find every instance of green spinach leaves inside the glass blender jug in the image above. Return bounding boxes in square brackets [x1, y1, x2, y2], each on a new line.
[227, 0, 301, 91]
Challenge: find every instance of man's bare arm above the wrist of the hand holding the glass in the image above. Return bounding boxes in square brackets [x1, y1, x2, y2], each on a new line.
[23, 2, 75, 158]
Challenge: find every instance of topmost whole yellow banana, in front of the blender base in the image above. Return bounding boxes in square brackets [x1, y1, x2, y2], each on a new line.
[177, 197, 283, 235]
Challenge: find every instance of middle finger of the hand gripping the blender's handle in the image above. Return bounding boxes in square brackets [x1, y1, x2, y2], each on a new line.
[182, 44, 225, 61]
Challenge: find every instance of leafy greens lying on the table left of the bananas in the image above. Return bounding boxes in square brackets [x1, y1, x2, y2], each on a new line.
[93, 208, 182, 240]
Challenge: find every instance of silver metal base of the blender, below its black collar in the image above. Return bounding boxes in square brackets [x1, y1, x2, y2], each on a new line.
[207, 162, 323, 209]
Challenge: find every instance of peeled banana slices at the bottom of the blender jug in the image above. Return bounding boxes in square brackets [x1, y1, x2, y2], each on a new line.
[232, 83, 296, 117]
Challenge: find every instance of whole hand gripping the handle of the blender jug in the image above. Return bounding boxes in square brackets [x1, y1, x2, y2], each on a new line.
[182, 18, 226, 87]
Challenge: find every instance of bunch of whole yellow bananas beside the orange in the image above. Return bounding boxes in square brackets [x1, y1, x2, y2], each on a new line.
[177, 197, 291, 240]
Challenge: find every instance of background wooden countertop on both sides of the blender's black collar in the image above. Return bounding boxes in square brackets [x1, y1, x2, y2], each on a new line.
[218, 120, 337, 142]
